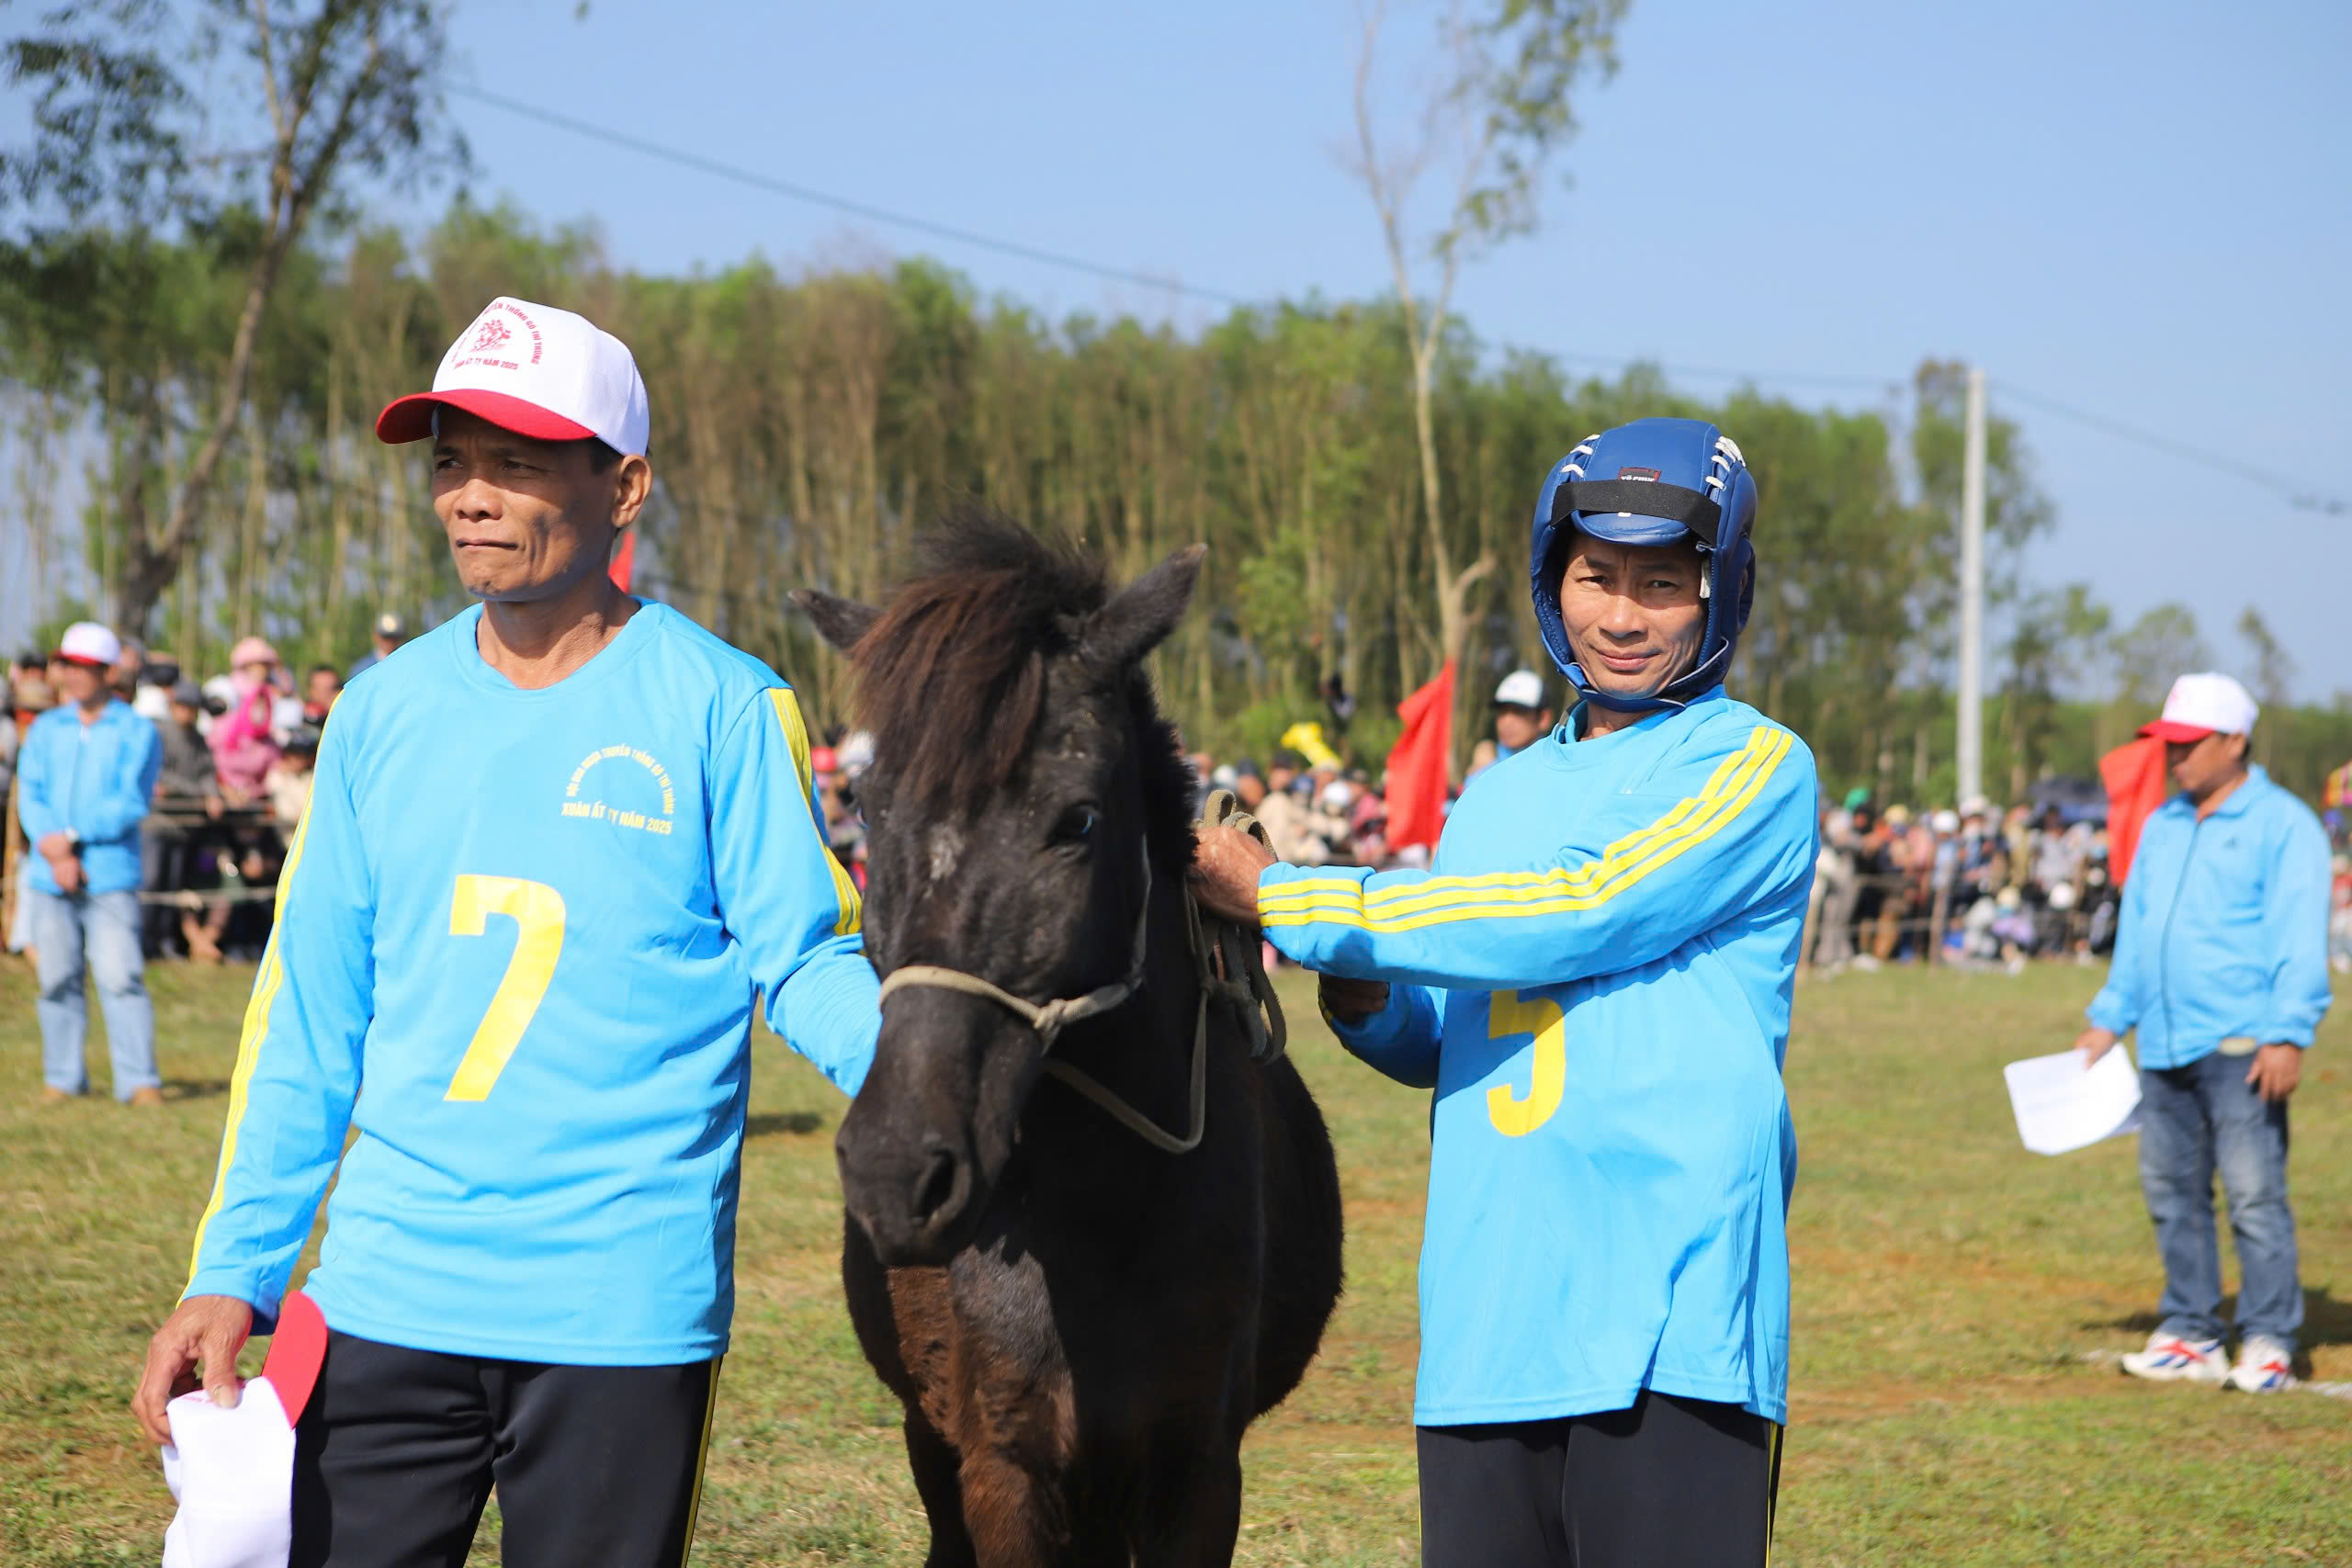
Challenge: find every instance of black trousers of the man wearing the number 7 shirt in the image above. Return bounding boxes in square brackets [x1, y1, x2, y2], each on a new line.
[289, 1333, 719, 1568]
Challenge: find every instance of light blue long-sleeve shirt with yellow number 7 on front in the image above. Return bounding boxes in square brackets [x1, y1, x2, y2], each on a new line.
[188, 604, 879, 1366]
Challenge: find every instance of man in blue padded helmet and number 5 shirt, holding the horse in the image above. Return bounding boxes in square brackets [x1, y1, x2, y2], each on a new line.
[1200, 419, 1818, 1568]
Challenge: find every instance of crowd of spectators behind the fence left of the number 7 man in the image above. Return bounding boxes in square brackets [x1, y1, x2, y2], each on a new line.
[0, 616, 407, 964]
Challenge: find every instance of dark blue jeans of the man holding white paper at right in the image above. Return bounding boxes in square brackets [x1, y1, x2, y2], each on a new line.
[2141, 1051, 2302, 1349]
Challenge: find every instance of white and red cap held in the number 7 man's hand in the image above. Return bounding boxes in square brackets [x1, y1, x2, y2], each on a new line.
[163, 1291, 327, 1568]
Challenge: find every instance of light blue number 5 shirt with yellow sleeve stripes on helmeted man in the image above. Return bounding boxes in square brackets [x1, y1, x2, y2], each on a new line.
[1259, 689, 1815, 1425]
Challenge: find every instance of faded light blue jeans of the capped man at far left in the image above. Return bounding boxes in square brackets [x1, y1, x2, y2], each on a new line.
[24, 888, 163, 1100]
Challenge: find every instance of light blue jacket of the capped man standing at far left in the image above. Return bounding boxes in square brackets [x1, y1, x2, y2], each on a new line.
[17, 701, 163, 894]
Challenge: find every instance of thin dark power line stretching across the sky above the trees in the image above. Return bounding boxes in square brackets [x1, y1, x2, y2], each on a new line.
[468, 94, 2352, 517]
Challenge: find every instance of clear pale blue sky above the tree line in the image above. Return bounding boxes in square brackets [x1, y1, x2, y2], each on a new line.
[5, 0, 2352, 698]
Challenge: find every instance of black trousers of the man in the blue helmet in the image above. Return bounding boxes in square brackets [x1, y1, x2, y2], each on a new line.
[1419, 1389, 1781, 1568]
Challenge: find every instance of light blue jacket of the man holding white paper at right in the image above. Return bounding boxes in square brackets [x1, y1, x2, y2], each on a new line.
[2088, 766, 2328, 1067]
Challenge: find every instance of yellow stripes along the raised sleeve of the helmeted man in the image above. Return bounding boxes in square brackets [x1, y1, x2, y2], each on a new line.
[1261, 724, 1794, 931]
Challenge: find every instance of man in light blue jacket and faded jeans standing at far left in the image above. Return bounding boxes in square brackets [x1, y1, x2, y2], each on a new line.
[17, 621, 163, 1105]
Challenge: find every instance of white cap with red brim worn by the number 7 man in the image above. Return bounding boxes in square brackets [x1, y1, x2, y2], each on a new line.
[377, 294, 654, 456]
